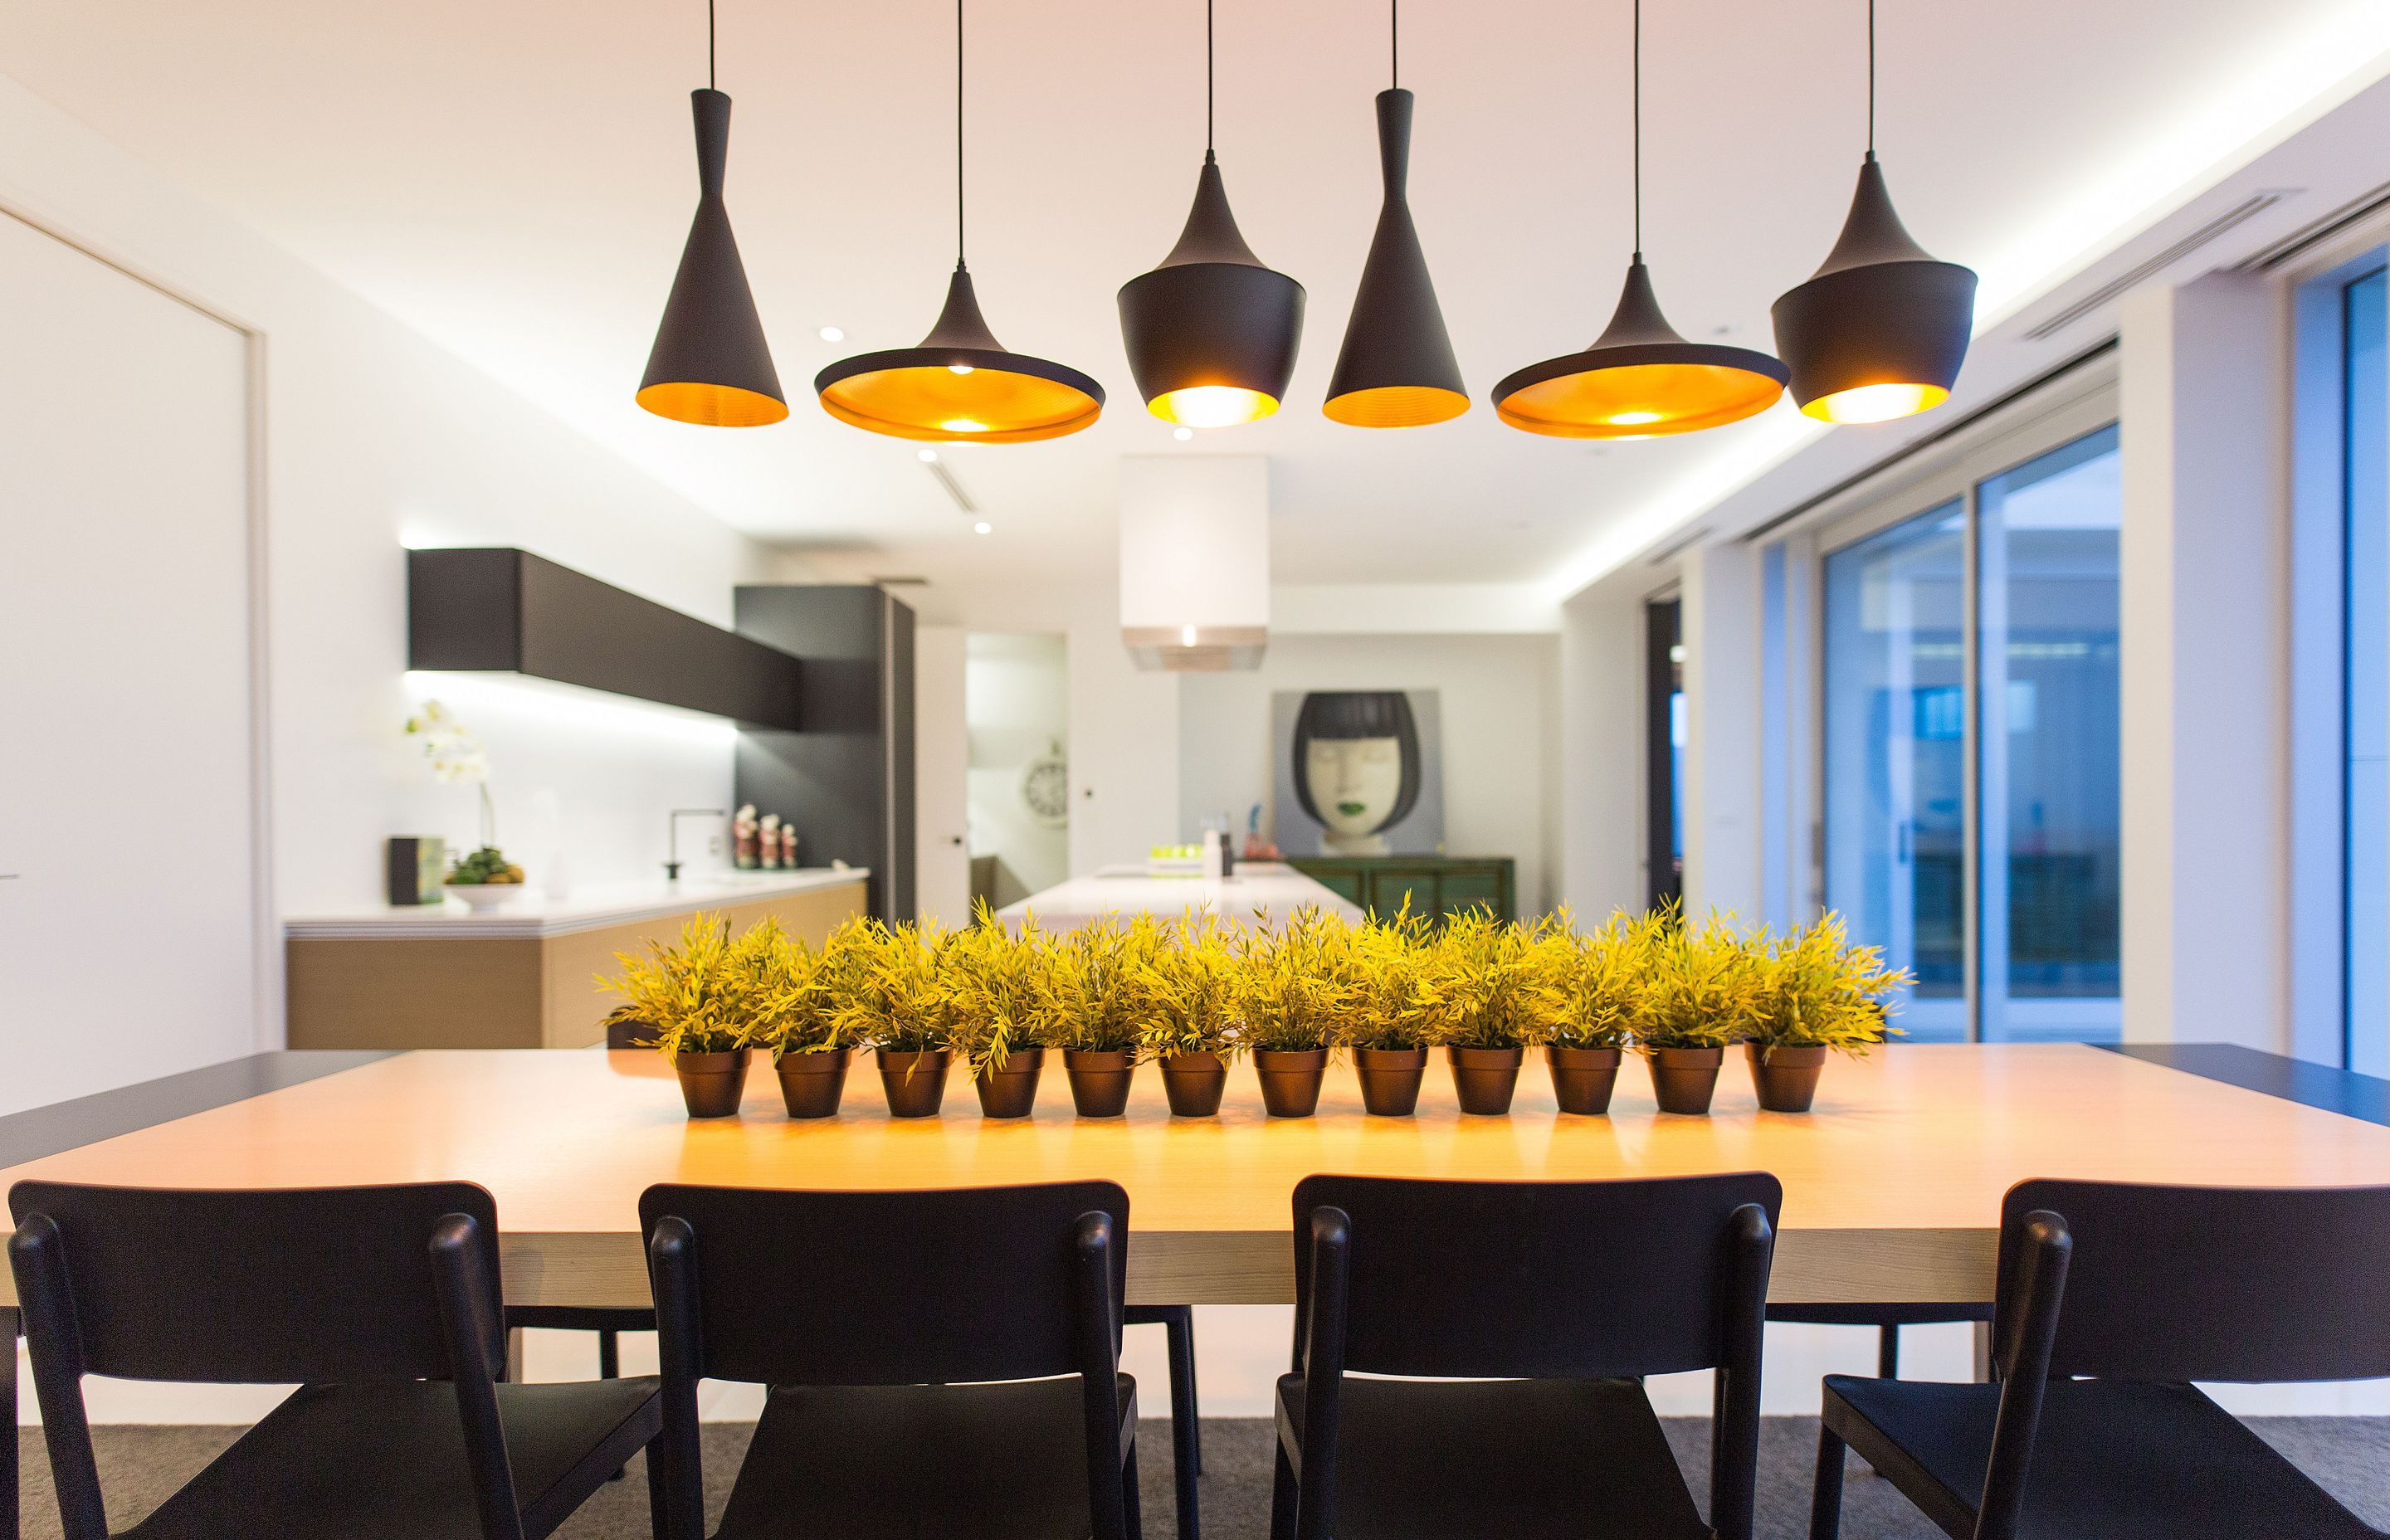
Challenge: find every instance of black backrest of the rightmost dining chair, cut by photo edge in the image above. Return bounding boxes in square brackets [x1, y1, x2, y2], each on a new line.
[1996, 1182, 2390, 1382]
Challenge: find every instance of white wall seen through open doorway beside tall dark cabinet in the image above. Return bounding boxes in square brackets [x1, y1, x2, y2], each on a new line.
[963, 631, 1071, 909]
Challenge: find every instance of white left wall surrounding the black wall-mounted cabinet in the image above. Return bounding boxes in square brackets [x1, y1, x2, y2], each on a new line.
[0, 79, 758, 961]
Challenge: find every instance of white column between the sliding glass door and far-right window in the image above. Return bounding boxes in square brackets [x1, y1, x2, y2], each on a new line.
[2118, 275, 2290, 1052]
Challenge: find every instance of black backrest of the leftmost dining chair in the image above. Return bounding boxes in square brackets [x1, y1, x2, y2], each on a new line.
[10, 1182, 505, 1385]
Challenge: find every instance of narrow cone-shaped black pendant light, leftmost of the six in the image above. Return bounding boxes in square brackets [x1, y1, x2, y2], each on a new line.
[638, 0, 788, 428]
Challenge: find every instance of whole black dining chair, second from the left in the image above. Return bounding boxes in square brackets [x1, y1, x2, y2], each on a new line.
[638, 1182, 1140, 1540]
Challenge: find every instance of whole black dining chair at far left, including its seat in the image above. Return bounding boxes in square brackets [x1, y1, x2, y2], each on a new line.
[10, 1182, 662, 1540]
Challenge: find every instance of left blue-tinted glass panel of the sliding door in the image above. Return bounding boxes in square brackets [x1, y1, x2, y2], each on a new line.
[1826, 502, 1967, 1043]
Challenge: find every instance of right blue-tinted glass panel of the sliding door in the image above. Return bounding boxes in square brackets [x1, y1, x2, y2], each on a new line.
[1977, 428, 2122, 1043]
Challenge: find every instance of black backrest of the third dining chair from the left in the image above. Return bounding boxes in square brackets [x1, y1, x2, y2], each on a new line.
[1295, 1172, 1783, 1377]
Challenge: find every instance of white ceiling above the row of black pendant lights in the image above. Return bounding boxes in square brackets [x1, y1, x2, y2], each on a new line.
[0, 0, 2380, 583]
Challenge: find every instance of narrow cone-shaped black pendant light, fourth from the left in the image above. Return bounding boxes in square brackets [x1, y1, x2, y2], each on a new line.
[1322, 0, 1470, 428]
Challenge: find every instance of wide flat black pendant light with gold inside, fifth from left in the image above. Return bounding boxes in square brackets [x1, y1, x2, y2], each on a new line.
[1494, 0, 1785, 437]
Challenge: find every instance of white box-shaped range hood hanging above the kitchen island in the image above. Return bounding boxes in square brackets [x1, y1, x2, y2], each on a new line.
[1121, 455, 1269, 672]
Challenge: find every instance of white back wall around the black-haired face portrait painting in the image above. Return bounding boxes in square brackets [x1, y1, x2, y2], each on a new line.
[1176, 636, 1561, 914]
